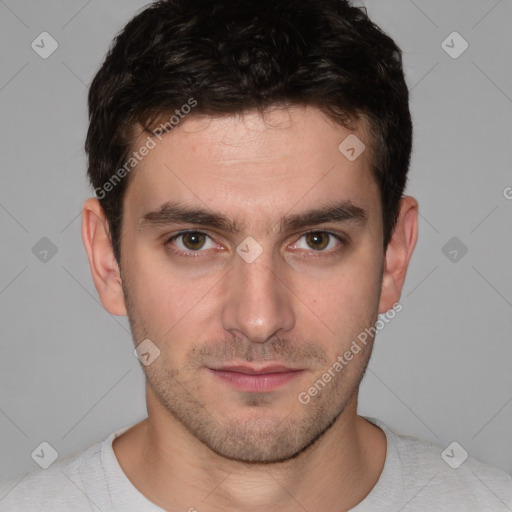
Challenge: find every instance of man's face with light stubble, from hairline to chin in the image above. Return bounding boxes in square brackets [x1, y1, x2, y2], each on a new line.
[121, 107, 384, 462]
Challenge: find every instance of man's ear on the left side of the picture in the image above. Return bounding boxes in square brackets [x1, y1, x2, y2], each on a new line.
[82, 198, 126, 316]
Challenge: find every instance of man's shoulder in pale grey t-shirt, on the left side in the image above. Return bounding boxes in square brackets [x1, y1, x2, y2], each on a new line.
[0, 435, 112, 512]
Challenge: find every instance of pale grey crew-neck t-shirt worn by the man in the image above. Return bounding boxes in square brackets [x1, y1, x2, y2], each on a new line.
[0, 418, 512, 512]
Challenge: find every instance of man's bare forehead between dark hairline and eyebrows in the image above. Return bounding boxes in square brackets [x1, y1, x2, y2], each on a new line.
[125, 107, 379, 226]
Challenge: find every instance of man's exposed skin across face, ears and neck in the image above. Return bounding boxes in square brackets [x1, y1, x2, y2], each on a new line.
[82, 107, 418, 512]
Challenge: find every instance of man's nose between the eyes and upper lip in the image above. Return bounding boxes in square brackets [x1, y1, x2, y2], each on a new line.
[222, 246, 295, 343]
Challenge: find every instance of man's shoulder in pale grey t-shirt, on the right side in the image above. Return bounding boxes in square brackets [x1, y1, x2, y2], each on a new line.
[377, 422, 512, 512]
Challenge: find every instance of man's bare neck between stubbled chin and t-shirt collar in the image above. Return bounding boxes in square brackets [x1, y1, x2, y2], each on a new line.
[113, 395, 386, 512]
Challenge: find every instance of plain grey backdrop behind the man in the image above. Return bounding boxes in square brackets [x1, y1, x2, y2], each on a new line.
[0, 0, 512, 481]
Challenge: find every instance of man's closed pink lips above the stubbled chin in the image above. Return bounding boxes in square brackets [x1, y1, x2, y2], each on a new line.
[208, 365, 305, 393]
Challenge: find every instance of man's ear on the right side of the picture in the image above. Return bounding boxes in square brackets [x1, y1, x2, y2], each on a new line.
[379, 196, 418, 313]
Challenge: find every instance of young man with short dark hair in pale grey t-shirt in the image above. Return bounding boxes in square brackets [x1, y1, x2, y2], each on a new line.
[0, 0, 512, 512]
